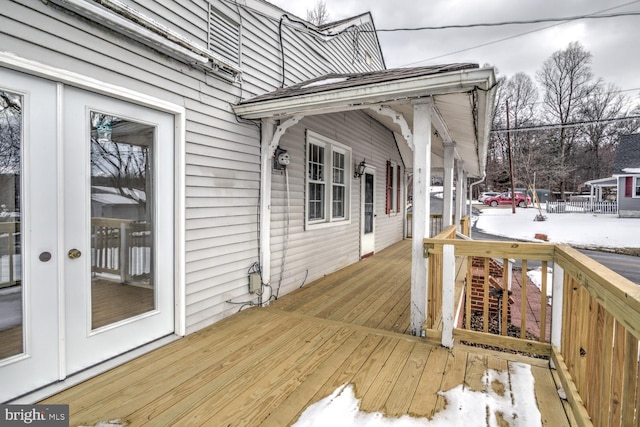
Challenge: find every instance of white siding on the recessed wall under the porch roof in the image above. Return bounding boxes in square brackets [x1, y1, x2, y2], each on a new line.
[271, 111, 403, 296]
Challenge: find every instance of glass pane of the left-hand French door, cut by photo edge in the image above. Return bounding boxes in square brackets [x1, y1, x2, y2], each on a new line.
[0, 90, 24, 359]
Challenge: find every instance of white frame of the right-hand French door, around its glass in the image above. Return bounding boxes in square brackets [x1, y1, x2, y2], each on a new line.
[60, 86, 175, 375]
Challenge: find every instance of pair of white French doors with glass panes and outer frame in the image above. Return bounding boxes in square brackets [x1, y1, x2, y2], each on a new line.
[0, 69, 174, 402]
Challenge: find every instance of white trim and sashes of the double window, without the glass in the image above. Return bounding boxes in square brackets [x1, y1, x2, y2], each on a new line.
[304, 129, 353, 230]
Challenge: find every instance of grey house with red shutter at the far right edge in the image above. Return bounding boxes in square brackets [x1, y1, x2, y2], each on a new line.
[613, 134, 640, 218]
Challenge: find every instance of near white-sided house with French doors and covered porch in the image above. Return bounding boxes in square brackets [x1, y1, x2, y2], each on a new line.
[0, 0, 495, 402]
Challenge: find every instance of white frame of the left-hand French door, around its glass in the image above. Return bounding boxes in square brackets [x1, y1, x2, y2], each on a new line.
[0, 65, 61, 402]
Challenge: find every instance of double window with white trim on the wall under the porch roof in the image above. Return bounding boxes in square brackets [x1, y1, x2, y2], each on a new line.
[305, 131, 351, 228]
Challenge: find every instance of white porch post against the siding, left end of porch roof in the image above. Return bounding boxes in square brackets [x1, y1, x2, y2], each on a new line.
[260, 119, 276, 290]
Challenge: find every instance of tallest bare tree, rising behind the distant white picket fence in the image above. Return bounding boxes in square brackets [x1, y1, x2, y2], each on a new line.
[537, 42, 600, 198]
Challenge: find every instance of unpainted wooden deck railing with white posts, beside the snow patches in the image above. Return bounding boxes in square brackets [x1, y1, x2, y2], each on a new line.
[425, 232, 640, 426]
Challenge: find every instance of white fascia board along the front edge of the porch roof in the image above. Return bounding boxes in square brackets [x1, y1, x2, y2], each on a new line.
[233, 68, 494, 119]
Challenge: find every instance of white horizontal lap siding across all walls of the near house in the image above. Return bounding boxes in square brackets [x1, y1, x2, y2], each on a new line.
[5, 0, 390, 333]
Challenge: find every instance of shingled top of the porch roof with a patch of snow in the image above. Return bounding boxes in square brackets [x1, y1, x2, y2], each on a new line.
[240, 63, 479, 105]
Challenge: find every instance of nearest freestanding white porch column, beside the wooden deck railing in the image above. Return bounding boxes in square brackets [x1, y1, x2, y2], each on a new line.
[411, 103, 432, 335]
